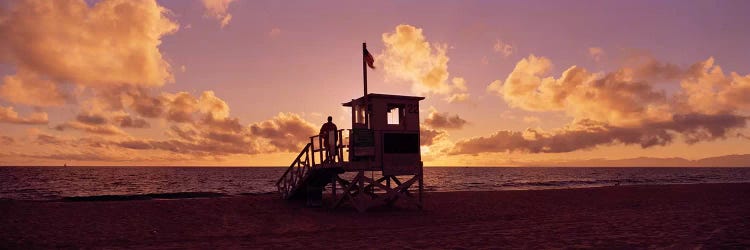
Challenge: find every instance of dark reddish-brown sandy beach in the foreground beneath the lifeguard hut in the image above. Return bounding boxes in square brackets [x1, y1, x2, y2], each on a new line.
[0, 184, 750, 249]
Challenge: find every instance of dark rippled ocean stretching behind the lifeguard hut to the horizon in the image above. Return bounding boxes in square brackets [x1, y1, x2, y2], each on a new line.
[0, 167, 750, 200]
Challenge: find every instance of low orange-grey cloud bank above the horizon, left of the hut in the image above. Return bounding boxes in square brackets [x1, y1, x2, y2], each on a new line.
[14, 110, 316, 161]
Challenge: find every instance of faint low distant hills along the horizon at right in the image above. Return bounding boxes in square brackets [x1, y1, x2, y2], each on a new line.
[523, 154, 750, 167]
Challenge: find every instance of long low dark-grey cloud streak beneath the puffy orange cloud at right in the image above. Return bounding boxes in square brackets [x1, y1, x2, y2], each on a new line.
[456, 114, 747, 155]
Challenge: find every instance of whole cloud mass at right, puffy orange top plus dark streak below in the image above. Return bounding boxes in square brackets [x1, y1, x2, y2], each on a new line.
[470, 55, 750, 154]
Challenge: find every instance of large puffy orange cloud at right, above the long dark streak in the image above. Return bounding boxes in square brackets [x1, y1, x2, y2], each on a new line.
[487, 55, 750, 125]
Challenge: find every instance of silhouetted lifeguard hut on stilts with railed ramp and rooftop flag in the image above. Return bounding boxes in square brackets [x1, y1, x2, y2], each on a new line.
[276, 44, 424, 212]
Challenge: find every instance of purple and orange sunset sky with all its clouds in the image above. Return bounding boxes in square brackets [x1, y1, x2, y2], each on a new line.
[0, 0, 750, 166]
